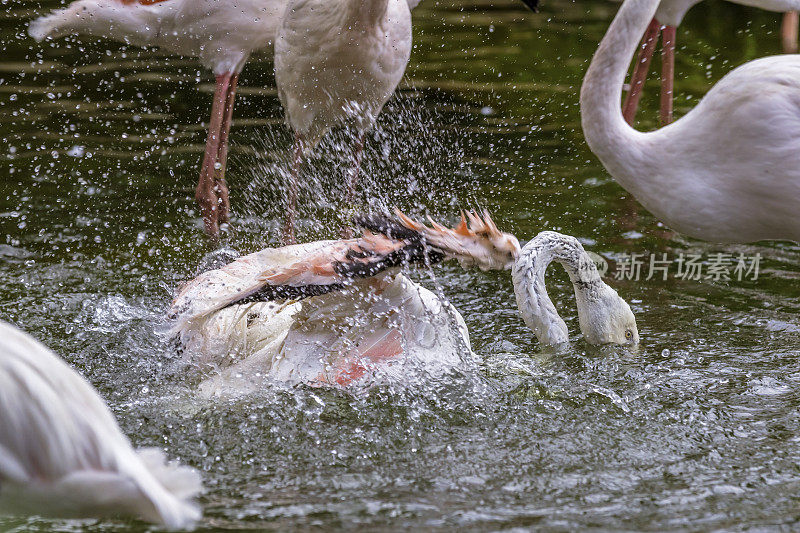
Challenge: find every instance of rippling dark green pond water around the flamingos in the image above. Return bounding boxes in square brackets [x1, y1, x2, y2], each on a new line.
[0, 0, 800, 531]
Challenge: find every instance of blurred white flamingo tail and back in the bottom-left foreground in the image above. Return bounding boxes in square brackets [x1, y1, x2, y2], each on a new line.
[0, 322, 202, 529]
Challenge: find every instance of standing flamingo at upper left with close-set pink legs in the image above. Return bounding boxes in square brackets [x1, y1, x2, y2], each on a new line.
[28, 0, 287, 240]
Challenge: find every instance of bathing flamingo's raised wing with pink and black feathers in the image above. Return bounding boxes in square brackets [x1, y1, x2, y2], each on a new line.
[170, 211, 520, 322]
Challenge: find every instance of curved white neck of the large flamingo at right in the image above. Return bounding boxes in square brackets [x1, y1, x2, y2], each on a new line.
[581, 0, 659, 181]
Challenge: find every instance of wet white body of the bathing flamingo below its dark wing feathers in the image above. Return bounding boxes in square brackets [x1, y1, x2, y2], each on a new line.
[171, 241, 470, 395]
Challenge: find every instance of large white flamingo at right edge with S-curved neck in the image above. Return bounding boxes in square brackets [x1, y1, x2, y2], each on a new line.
[581, 0, 800, 242]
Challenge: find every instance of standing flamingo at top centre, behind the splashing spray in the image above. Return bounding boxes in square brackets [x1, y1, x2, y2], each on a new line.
[275, 0, 538, 244]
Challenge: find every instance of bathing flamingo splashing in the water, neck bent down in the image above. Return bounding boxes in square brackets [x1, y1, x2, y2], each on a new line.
[169, 212, 639, 396]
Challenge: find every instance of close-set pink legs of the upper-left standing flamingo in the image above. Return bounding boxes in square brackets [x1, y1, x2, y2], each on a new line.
[195, 73, 231, 240]
